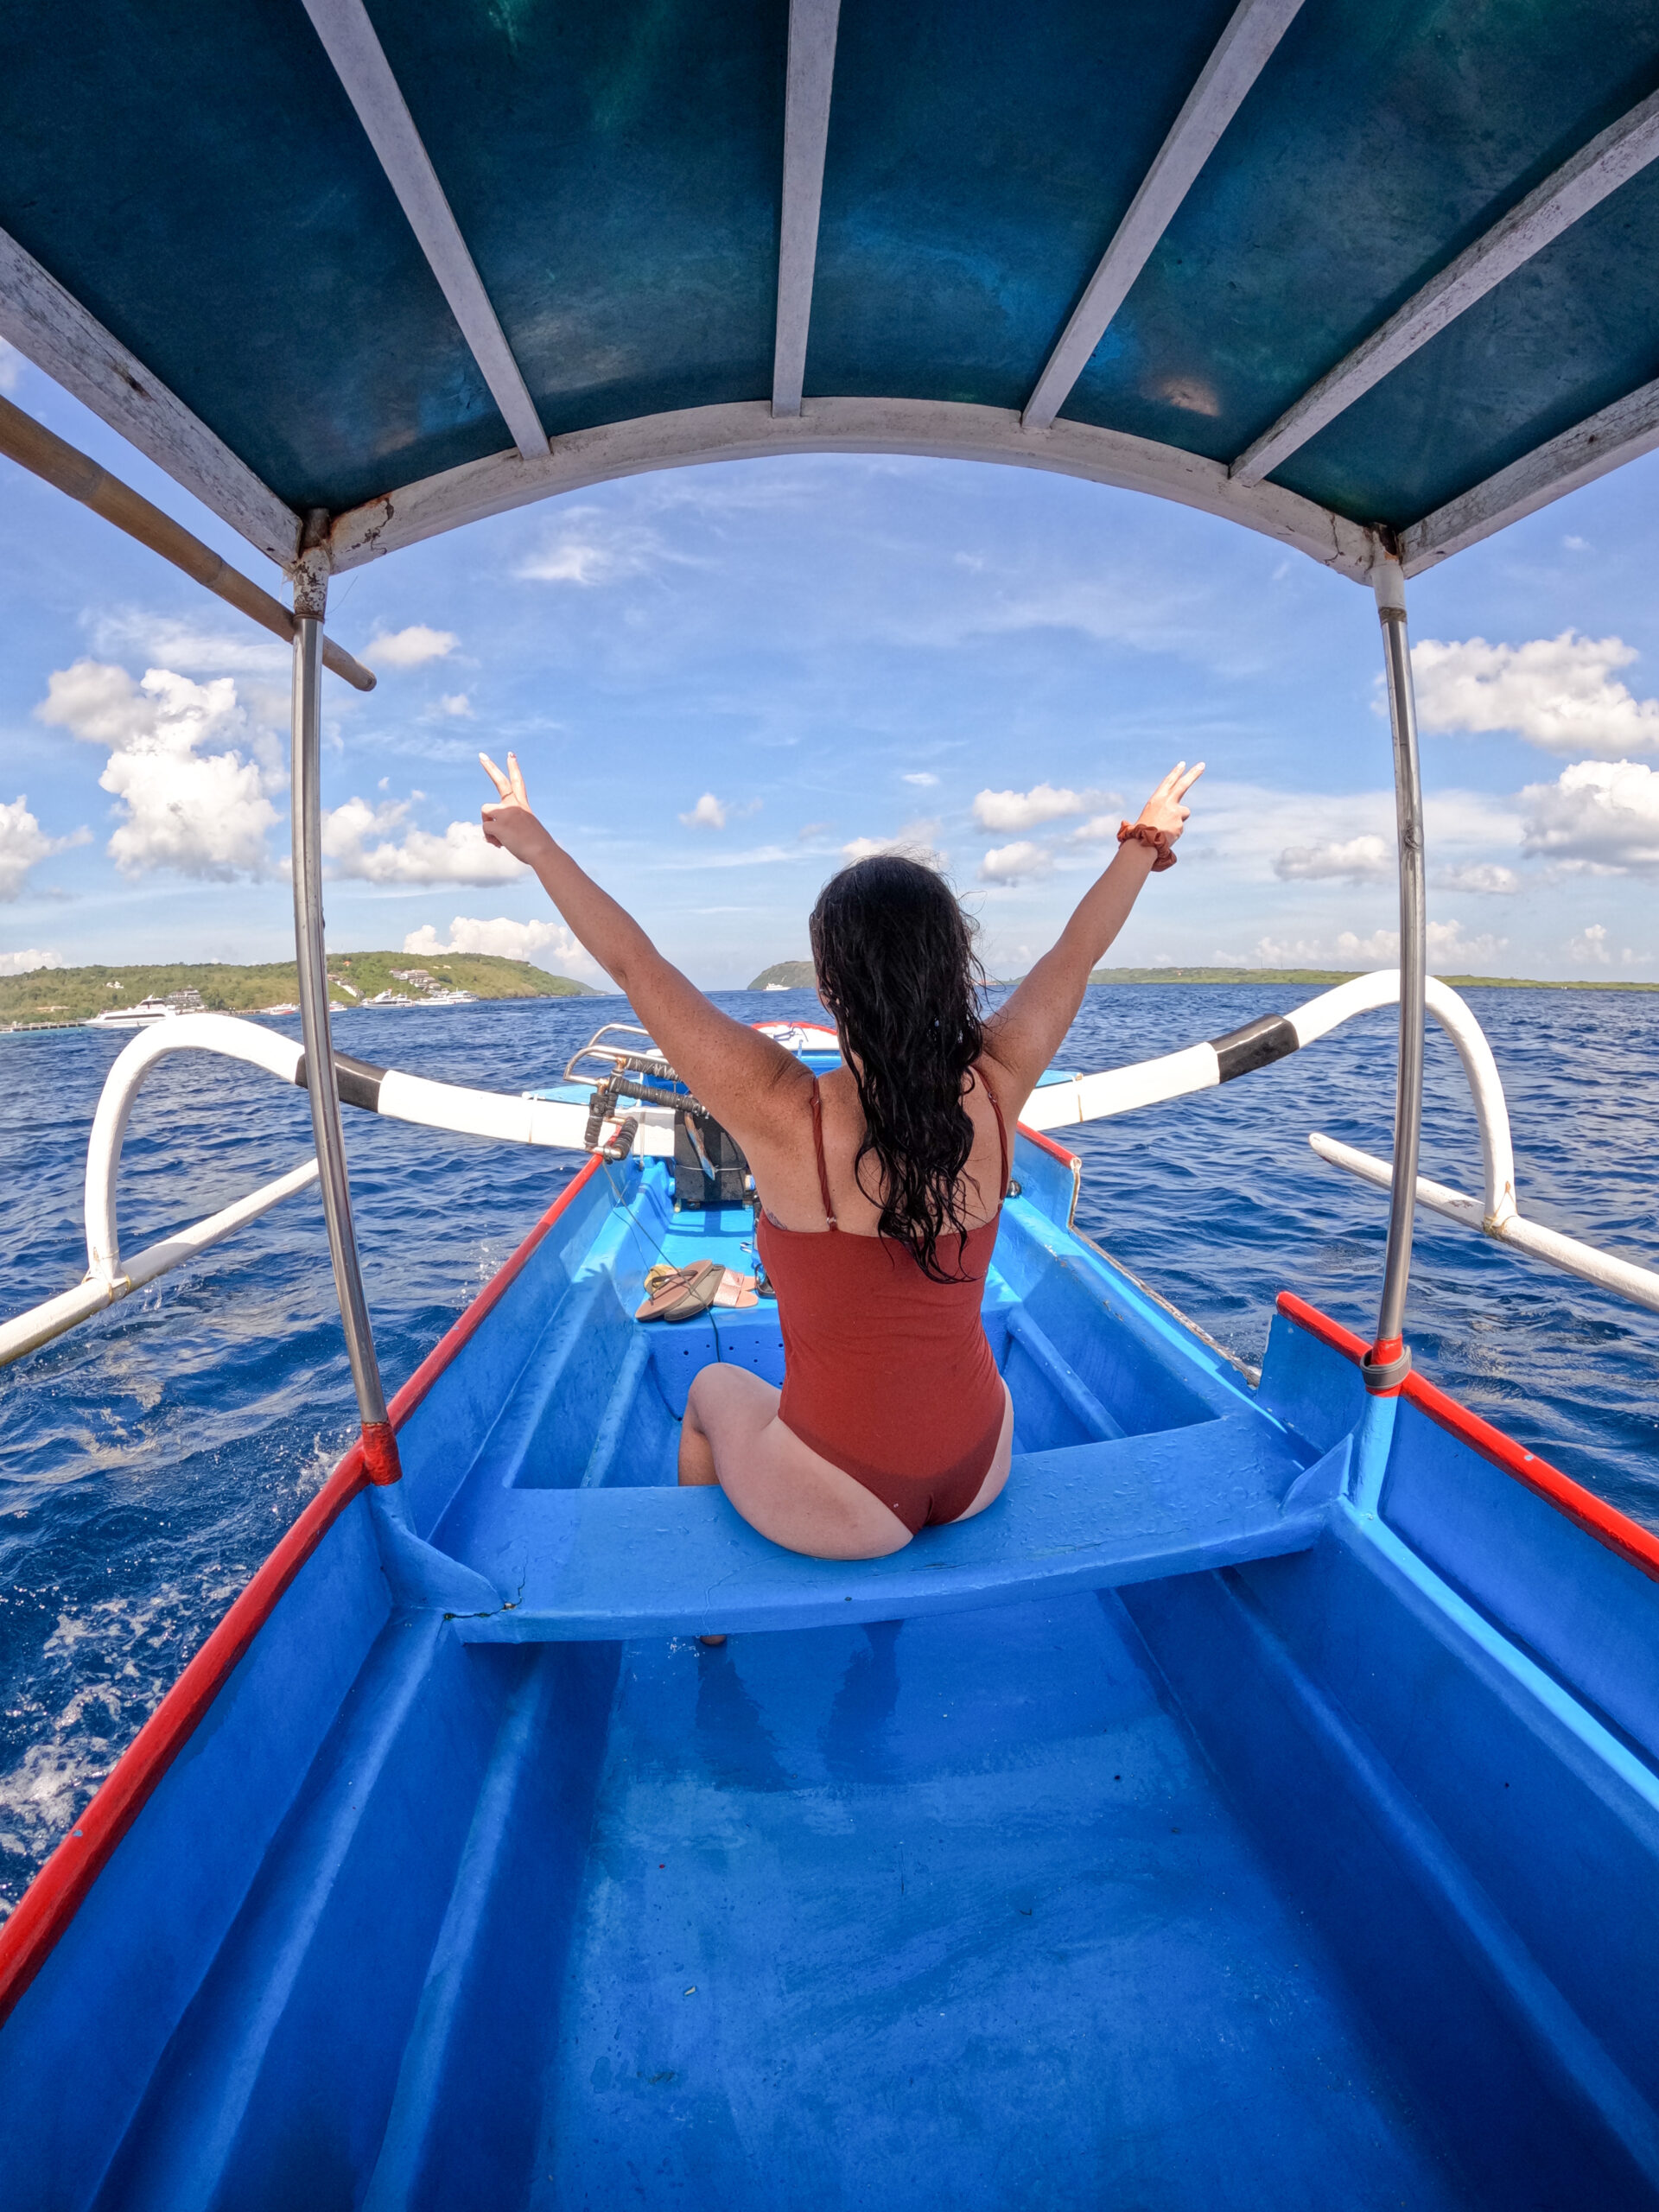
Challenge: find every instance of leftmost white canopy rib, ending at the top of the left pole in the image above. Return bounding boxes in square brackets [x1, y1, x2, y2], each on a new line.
[0, 230, 301, 569]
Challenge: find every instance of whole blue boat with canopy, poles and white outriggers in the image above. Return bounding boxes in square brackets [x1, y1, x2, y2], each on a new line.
[0, 0, 1659, 2212]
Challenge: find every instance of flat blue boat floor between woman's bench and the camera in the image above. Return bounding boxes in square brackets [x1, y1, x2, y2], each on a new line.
[531, 1595, 1465, 2212]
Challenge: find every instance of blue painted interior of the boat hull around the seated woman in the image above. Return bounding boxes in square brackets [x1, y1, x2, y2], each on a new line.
[0, 1137, 1659, 2212]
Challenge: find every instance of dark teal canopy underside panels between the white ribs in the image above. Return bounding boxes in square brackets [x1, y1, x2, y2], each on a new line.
[0, 0, 1659, 543]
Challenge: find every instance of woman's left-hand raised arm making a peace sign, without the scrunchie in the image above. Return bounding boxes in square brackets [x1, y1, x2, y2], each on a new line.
[478, 752, 807, 1150]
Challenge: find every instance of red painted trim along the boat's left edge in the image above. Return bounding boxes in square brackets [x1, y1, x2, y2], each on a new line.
[0, 1153, 601, 2022]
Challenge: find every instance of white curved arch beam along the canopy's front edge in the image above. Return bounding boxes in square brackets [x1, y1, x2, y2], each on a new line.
[329, 398, 1376, 584]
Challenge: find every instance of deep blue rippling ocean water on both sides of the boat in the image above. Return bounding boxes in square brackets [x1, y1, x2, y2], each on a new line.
[0, 982, 1659, 1913]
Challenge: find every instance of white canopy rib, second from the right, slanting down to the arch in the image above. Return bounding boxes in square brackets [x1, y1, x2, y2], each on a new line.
[1232, 93, 1659, 485]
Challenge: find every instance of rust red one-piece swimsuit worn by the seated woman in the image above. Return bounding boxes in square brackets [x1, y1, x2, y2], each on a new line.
[754, 1075, 1008, 1535]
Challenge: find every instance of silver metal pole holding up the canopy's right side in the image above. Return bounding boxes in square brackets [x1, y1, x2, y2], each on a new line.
[1365, 553, 1429, 1394]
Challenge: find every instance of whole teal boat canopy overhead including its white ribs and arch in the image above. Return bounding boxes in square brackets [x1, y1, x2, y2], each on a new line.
[0, 0, 1659, 580]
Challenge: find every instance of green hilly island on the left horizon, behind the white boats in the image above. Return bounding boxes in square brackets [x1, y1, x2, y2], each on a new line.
[0, 953, 600, 1028]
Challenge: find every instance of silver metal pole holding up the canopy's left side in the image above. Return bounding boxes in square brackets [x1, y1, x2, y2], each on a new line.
[294, 518, 403, 1482]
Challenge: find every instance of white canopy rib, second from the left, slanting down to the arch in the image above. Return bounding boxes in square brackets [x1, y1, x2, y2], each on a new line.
[305, 0, 546, 460]
